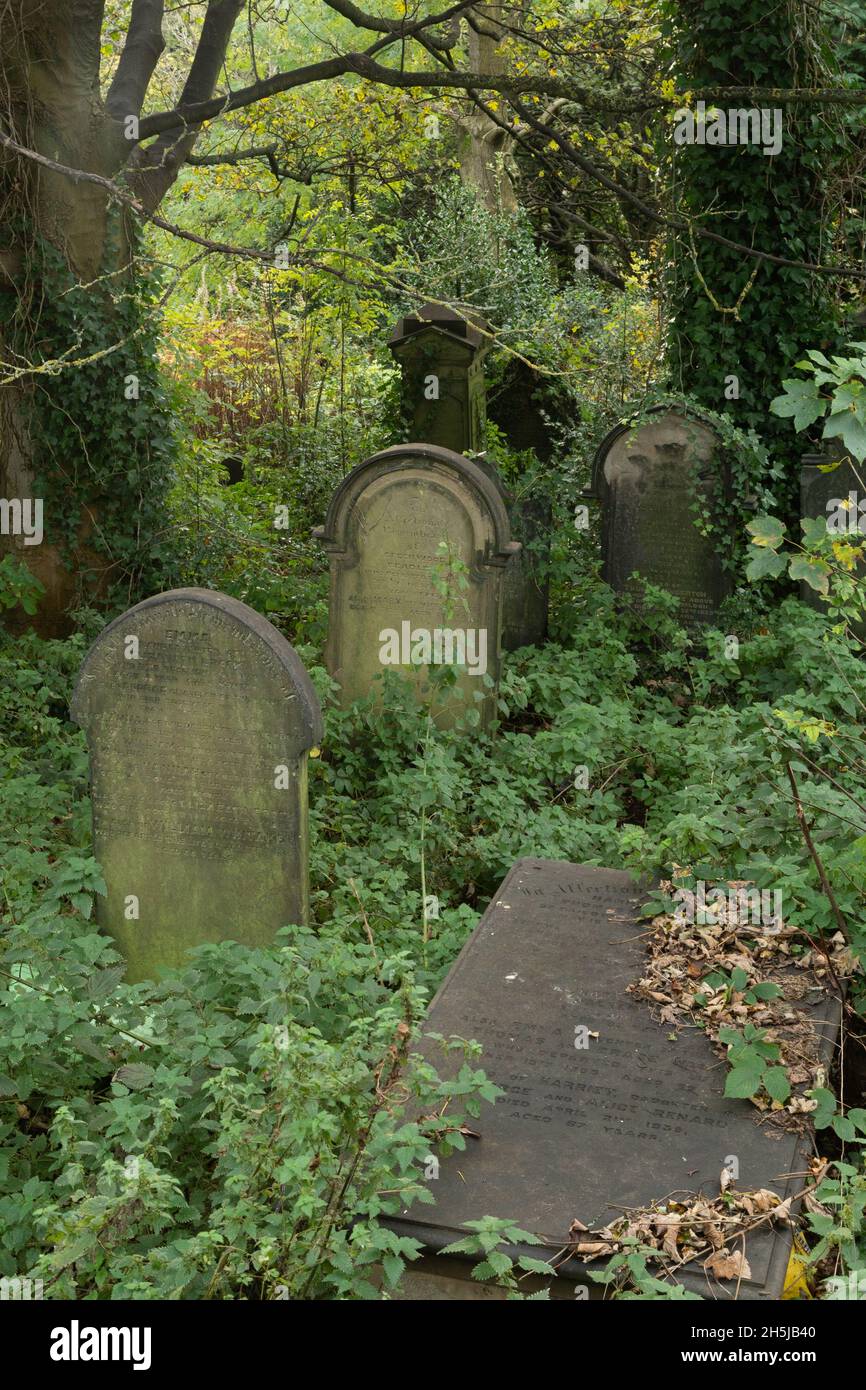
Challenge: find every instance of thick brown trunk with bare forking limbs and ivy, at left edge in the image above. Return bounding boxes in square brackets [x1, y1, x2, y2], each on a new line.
[0, 0, 242, 635]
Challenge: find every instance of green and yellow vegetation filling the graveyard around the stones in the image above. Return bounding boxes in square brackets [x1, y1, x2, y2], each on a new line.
[0, 0, 866, 1298]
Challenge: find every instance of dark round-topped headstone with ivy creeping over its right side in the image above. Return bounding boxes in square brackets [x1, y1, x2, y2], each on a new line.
[584, 409, 731, 628]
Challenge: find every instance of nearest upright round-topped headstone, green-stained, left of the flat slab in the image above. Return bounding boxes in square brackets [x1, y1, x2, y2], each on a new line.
[71, 589, 322, 981]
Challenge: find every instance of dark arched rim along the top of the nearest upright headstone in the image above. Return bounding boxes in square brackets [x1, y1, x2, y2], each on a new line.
[70, 588, 324, 751]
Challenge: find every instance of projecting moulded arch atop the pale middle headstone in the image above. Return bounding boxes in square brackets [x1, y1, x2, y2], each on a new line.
[313, 443, 520, 560]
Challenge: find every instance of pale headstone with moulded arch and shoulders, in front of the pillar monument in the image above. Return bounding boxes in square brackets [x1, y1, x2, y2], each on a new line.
[313, 445, 518, 727]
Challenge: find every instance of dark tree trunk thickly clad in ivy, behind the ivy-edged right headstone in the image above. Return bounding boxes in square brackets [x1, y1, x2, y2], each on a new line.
[667, 0, 838, 502]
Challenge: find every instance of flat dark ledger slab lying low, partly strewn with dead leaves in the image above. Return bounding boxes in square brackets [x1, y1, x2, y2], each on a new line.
[389, 859, 833, 1298]
